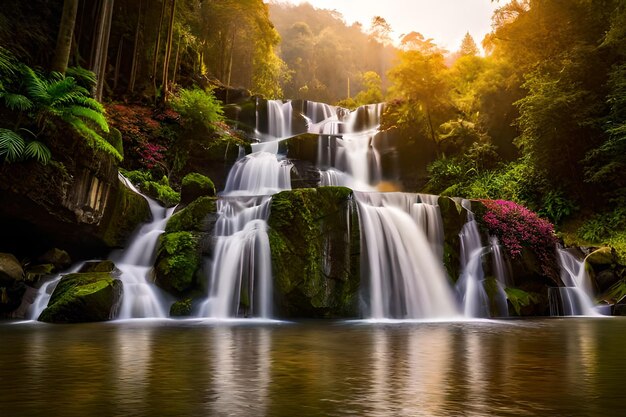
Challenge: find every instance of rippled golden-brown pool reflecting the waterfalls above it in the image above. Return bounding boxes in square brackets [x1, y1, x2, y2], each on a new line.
[0, 318, 626, 416]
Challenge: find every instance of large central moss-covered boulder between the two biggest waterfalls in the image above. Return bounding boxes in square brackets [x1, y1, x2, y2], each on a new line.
[268, 187, 360, 317]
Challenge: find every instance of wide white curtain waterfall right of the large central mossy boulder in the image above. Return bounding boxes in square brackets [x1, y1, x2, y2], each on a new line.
[355, 192, 458, 319]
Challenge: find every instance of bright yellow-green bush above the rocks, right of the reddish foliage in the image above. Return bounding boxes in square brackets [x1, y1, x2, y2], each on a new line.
[171, 88, 224, 131]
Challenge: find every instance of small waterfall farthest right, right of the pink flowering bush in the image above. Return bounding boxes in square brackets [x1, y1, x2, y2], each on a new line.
[548, 248, 599, 316]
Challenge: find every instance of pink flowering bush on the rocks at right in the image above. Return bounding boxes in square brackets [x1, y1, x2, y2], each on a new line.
[481, 200, 556, 275]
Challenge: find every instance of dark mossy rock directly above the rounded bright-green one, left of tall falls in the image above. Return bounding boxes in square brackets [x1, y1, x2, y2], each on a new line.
[165, 197, 217, 233]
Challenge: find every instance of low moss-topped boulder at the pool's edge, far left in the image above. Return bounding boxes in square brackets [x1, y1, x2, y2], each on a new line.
[38, 272, 122, 323]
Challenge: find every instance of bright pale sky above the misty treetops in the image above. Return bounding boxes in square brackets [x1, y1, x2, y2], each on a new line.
[270, 0, 501, 52]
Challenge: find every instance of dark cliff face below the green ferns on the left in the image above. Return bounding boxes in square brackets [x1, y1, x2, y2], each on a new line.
[0, 118, 150, 258]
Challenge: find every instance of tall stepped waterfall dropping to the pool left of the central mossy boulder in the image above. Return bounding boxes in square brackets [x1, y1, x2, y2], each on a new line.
[197, 106, 292, 319]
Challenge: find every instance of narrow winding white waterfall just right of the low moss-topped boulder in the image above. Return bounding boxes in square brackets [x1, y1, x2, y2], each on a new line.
[109, 196, 174, 319]
